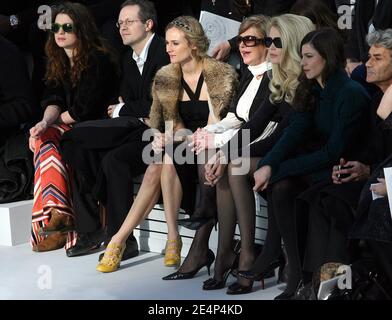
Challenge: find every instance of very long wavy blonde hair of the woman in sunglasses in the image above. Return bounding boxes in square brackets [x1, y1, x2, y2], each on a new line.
[269, 14, 315, 104]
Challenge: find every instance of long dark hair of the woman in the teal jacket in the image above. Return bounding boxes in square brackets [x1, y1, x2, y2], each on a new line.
[293, 28, 346, 111]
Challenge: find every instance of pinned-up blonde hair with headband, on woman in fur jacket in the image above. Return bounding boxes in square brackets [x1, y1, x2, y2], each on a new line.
[165, 16, 210, 60]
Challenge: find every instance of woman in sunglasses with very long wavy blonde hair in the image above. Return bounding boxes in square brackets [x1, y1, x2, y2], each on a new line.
[194, 14, 314, 294]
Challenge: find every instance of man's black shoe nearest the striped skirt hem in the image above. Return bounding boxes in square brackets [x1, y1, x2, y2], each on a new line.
[66, 230, 106, 257]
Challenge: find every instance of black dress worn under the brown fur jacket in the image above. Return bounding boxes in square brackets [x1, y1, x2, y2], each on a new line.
[174, 74, 209, 214]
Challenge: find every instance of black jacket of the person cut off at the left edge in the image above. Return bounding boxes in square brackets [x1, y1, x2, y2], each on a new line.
[0, 36, 35, 131]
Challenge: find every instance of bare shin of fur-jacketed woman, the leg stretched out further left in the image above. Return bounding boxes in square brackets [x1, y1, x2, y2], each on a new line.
[110, 164, 162, 244]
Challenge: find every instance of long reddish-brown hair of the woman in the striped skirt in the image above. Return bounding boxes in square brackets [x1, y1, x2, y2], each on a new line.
[45, 2, 116, 86]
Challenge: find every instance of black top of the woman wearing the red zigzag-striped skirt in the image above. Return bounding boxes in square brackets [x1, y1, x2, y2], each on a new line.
[41, 51, 119, 122]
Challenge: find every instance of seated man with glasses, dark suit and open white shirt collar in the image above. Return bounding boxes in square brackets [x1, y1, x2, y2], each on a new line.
[62, 0, 169, 260]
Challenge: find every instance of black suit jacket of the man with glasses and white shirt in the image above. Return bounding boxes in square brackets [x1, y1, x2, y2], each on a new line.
[120, 34, 170, 118]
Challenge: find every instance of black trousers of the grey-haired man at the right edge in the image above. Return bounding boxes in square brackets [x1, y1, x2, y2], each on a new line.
[296, 181, 364, 272]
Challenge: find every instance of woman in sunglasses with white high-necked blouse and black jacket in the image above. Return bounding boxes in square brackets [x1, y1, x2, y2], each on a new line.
[163, 15, 270, 280]
